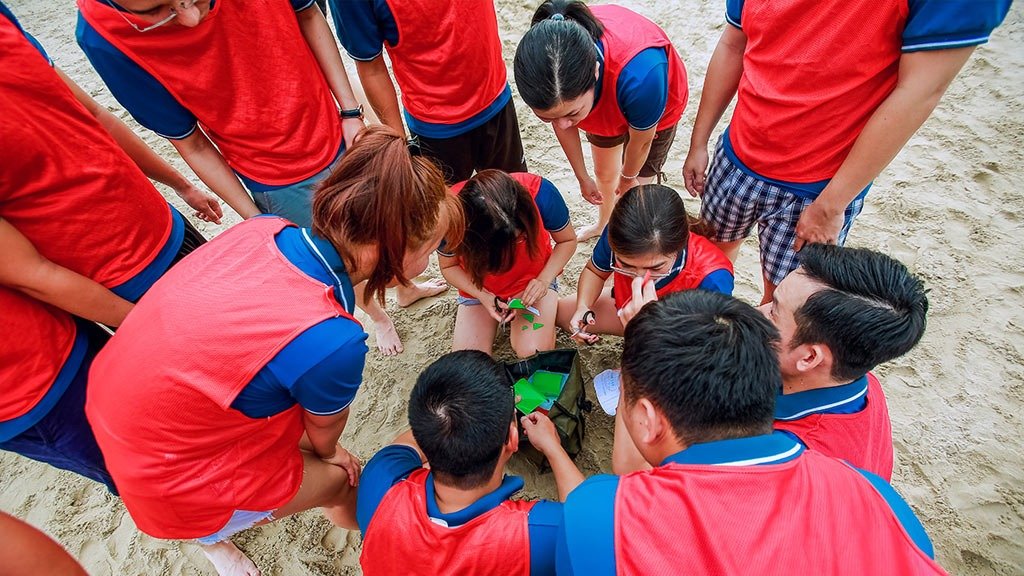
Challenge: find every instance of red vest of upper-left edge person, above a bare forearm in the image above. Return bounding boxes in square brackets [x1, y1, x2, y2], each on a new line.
[0, 17, 173, 288]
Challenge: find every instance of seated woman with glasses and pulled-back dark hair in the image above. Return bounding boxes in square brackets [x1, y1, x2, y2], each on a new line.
[558, 184, 733, 343]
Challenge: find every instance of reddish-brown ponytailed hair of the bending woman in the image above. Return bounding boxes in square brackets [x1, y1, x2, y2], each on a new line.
[312, 126, 464, 304]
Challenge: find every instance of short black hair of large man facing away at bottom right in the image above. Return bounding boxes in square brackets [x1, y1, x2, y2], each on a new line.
[622, 290, 782, 445]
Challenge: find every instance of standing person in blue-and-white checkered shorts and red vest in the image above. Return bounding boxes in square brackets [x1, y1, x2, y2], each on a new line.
[683, 0, 1011, 303]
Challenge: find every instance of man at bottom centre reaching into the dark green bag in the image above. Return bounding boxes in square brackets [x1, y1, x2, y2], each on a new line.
[355, 351, 583, 576]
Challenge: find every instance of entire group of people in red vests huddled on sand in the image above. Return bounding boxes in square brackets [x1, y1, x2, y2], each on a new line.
[0, 0, 1010, 576]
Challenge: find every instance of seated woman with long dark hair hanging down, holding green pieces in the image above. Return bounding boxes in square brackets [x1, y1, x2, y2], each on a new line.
[438, 170, 577, 358]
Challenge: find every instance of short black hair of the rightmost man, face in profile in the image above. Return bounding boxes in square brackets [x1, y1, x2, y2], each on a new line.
[792, 244, 928, 382]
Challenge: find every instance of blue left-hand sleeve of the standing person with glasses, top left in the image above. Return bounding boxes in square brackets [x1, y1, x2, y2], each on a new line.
[76, 13, 197, 139]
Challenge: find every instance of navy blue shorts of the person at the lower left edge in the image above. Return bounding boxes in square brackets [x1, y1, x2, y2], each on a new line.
[0, 323, 118, 494]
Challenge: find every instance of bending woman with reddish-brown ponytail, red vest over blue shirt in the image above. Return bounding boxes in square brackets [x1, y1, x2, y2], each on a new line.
[86, 127, 462, 574]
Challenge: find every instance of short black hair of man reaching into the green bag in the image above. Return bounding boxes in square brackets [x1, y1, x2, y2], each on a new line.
[409, 351, 515, 490]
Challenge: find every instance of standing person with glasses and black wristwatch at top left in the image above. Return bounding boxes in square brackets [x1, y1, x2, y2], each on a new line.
[77, 0, 444, 354]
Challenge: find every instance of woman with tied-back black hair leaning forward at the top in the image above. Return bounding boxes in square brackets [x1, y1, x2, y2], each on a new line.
[515, 0, 688, 241]
